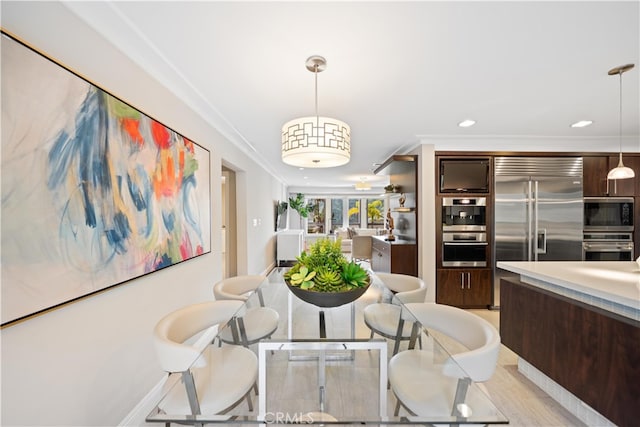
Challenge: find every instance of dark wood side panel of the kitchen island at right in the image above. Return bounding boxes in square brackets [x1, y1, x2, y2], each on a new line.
[500, 279, 640, 426]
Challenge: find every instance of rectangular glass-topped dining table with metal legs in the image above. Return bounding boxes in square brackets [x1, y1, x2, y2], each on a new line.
[146, 268, 509, 425]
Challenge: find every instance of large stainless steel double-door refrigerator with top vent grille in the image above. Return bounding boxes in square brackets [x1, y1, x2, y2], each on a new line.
[493, 157, 583, 308]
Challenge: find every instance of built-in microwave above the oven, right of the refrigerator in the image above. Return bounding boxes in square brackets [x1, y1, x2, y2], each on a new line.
[584, 197, 634, 231]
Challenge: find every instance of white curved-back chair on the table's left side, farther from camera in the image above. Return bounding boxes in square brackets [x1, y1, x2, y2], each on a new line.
[213, 275, 279, 347]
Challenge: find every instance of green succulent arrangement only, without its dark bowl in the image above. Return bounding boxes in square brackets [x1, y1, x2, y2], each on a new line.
[284, 239, 370, 292]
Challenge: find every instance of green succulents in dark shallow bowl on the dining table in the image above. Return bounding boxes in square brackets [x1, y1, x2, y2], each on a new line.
[284, 239, 371, 307]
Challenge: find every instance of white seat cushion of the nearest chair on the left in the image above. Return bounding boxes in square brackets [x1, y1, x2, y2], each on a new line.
[159, 345, 258, 414]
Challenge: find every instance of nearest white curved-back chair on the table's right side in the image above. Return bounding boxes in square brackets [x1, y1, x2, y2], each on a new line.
[389, 303, 500, 416]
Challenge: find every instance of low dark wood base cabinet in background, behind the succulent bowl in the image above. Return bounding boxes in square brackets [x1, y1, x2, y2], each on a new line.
[371, 236, 418, 277]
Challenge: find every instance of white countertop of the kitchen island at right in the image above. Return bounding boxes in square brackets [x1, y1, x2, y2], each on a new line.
[497, 261, 640, 310]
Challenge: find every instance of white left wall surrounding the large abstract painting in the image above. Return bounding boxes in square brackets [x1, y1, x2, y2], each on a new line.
[0, 1, 286, 426]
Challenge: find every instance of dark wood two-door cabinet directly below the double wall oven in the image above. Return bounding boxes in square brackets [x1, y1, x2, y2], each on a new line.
[436, 268, 492, 308]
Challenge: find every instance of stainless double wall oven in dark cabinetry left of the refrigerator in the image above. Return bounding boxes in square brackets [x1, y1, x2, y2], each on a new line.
[442, 197, 487, 267]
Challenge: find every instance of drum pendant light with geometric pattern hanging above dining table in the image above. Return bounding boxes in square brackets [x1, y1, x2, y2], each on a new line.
[282, 55, 351, 168]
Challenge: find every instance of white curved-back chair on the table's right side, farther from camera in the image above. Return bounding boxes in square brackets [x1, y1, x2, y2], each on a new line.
[364, 273, 427, 355]
